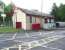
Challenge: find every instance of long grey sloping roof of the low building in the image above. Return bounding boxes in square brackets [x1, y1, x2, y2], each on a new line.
[14, 8, 54, 17]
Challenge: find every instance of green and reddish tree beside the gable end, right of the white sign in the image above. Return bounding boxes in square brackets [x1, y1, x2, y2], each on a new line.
[4, 4, 14, 24]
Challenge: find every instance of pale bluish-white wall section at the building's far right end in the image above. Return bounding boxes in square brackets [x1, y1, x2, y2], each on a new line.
[42, 18, 55, 29]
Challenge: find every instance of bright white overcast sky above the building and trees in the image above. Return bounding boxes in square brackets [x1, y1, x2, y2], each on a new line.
[2, 0, 65, 14]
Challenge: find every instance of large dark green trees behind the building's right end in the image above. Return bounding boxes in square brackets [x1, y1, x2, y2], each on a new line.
[51, 3, 65, 21]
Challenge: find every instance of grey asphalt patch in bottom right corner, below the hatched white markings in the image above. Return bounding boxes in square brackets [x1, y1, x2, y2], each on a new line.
[46, 38, 65, 50]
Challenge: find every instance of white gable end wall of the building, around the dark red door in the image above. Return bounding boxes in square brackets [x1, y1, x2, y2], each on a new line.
[13, 10, 26, 30]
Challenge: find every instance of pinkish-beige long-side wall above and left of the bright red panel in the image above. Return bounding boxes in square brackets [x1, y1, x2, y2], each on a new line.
[26, 16, 41, 30]
